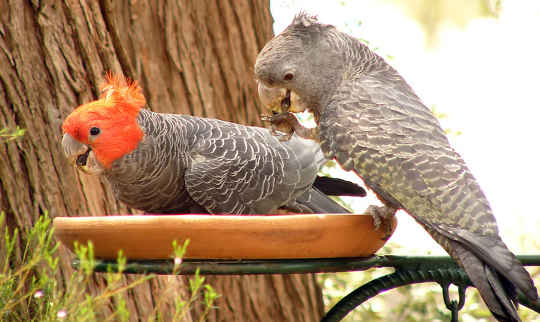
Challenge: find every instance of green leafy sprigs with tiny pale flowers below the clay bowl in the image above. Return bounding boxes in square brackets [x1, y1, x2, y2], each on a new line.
[0, 213, 218, 321]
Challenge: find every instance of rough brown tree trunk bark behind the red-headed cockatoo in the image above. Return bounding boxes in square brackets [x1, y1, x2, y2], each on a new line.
[0, 0, 322, 321]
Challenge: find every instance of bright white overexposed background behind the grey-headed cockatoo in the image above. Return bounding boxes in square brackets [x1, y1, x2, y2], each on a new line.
[271, 0, 540, 254]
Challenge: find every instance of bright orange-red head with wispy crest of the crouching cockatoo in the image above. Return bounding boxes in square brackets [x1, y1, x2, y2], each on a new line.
[62, 74, 146, 168]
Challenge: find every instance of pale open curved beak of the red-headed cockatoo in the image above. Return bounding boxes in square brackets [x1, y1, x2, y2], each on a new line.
[62, 133, 103, 174]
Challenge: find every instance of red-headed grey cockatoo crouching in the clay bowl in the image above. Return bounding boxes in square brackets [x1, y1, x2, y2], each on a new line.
[62, 77, 365, 214]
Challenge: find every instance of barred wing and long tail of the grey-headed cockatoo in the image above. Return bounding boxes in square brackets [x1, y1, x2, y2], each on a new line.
[320, 75, 537, 320]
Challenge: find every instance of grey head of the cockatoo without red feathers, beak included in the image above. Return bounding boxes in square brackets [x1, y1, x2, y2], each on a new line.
[255, 12, 364, 112]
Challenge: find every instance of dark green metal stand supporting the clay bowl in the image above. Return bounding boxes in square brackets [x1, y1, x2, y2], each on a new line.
[73, 255, 540, 322]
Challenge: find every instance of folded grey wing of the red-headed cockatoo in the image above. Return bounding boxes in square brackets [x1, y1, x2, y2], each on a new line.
[185, 122, 348, 214]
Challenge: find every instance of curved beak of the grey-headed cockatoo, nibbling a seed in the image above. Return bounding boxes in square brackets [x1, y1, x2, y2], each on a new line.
[257, 80, 307, 114]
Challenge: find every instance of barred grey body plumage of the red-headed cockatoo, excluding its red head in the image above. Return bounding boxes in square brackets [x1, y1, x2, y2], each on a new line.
[63, 105, 348, 214]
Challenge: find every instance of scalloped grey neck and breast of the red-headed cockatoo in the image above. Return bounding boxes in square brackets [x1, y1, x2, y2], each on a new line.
[104, 110, 191, 210]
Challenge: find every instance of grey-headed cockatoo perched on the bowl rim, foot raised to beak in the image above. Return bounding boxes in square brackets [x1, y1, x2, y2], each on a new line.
[255, 13, 538, 321]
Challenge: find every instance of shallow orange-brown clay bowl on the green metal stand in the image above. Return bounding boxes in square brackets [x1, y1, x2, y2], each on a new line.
[53, 214, 397, 259]
